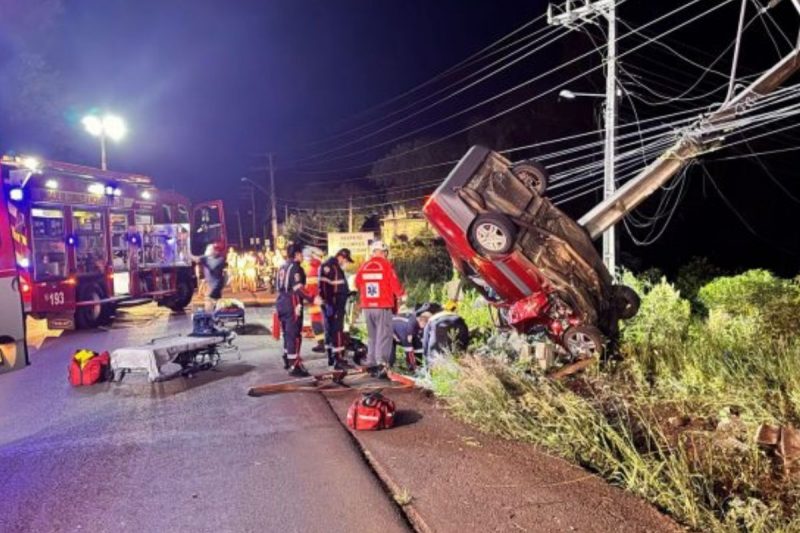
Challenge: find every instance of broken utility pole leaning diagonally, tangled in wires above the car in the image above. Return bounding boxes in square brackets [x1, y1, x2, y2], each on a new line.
[578, 46, 800, 239]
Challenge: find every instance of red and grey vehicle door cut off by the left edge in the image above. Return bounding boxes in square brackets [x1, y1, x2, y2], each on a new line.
[0, 193, 28, 373]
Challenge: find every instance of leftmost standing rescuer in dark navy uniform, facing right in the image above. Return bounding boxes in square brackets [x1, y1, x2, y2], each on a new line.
[275, 245, 319, 377]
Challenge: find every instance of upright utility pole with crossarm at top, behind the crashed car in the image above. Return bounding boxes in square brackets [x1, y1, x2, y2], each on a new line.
[547, 0, 618, 276]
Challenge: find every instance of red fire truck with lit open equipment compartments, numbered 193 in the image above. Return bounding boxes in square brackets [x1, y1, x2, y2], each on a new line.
[0, 156, 226, 337]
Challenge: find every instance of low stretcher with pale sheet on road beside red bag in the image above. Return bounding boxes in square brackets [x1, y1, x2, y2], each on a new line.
[111, 330, 240, 382]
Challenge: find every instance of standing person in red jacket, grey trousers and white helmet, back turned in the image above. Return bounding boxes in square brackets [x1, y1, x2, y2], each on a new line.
[355, 241, 405, 375]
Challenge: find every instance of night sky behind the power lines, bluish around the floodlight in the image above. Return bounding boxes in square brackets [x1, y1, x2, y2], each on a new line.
[0, 0, 800, 275]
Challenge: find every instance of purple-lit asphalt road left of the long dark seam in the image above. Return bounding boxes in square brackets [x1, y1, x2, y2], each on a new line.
[0, 306, 408, 533]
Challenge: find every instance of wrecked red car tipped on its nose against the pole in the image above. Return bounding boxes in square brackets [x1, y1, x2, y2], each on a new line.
[424, 146, 639, 359]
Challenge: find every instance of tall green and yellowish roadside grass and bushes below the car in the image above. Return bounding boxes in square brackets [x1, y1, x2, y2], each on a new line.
[428, 272, 800, 532]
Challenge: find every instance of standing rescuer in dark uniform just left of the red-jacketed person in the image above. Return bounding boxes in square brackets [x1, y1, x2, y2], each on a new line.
[319, 248, 353, 370]
